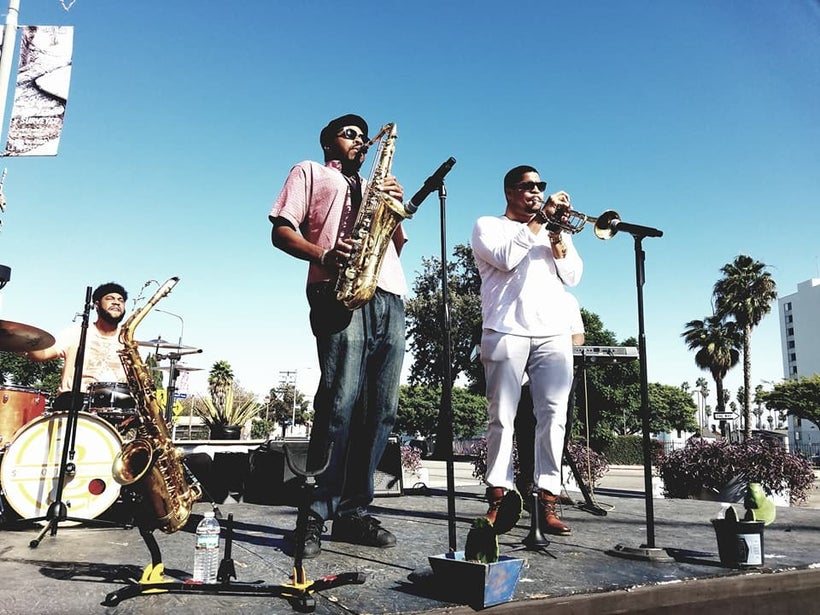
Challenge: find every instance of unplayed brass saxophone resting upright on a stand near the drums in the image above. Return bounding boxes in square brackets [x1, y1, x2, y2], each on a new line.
[112, 277, 202, 534]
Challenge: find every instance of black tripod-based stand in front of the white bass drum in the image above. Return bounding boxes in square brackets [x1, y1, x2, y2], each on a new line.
[27, 286, 130, 549]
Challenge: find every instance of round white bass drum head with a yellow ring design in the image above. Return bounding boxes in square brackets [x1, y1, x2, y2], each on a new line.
[0, 412, 122, 525]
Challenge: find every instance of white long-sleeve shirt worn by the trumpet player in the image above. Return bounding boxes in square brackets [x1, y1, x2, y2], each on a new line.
[471, 216, 584, 337]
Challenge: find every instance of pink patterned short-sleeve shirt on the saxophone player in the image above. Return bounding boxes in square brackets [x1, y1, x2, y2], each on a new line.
[268, 160, 407, 295]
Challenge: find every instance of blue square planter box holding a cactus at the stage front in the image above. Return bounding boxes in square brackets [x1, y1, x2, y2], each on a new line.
[428, 551, 524, 608]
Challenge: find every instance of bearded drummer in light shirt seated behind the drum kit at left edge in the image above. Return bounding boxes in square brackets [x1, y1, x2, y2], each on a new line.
[21, 282, 128, 410]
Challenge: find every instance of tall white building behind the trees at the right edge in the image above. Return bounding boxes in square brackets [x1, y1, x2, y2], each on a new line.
[777, 278, 820, 455]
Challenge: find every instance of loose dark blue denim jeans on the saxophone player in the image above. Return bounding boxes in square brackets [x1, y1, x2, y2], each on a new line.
[308, 284, 405, 519]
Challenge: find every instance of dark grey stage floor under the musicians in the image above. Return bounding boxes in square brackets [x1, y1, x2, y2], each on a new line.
[0, 474, 820, 615]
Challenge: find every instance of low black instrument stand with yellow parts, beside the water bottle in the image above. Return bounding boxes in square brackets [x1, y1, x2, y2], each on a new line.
[102, 444, 366, 613]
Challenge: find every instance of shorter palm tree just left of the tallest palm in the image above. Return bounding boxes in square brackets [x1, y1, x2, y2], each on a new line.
[681, 315, 741, 422]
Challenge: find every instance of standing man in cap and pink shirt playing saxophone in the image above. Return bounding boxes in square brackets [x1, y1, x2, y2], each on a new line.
[268, 114, 407, 558]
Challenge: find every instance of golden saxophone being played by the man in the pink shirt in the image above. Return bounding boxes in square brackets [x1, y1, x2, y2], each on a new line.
[336, 123, 411, 310]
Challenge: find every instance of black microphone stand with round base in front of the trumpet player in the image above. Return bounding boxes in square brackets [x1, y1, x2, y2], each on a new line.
[606, 220, 675, 562]
